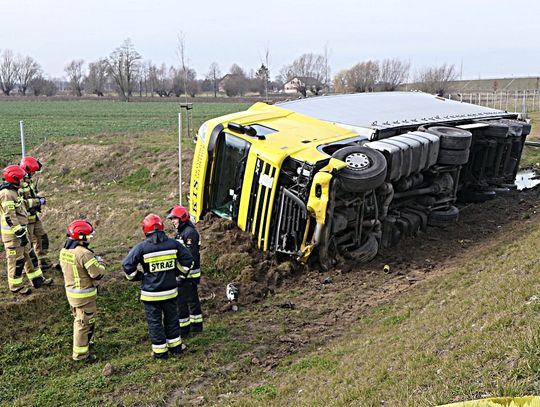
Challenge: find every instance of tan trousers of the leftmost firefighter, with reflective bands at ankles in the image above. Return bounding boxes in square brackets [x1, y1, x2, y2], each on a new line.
[2, 234, 43, 292]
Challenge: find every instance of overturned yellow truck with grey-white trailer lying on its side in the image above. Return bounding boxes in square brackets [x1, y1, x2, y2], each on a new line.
[190, 92, 531, 269]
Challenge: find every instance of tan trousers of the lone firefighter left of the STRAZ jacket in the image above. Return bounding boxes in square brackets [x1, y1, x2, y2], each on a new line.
[71, 298, 97, 360]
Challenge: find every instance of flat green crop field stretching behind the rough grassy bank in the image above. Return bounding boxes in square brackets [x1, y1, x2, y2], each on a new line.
[0, 100, 249, 165]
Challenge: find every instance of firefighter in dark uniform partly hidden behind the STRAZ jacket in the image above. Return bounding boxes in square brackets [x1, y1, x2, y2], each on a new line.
[167, 205, 203, 338]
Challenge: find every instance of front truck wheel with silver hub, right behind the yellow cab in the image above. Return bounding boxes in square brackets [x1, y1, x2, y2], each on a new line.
[332, 146, 386, 192]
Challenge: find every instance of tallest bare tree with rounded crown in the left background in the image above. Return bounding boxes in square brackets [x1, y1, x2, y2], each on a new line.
[107, 38, 142, 102]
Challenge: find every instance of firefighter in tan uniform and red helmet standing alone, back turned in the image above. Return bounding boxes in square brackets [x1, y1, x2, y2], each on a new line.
[60, 219, 105, 362]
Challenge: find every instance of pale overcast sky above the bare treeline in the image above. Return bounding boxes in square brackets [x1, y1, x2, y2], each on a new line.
[0, 0, 540, 79]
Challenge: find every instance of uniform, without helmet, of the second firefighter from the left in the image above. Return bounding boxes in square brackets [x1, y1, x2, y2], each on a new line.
[19, 177, 50, 271]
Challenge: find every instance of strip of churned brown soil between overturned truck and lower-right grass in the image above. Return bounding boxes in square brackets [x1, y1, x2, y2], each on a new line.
[167, 189, 540, 405]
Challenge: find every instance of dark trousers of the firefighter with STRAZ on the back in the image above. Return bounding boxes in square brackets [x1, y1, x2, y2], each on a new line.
[143, 298, 182, 359]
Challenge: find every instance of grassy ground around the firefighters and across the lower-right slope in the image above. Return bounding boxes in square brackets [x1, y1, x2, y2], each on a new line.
[0, 101, 540, 406]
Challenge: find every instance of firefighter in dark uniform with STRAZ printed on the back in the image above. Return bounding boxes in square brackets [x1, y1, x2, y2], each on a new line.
[122, 213, 193, 359]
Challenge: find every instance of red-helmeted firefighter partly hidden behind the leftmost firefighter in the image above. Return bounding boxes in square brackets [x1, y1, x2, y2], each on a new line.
[19, 156, 51, 272]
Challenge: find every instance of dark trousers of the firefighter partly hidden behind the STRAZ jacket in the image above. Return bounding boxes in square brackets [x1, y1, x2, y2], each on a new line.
[177, 278, 203, 337]
